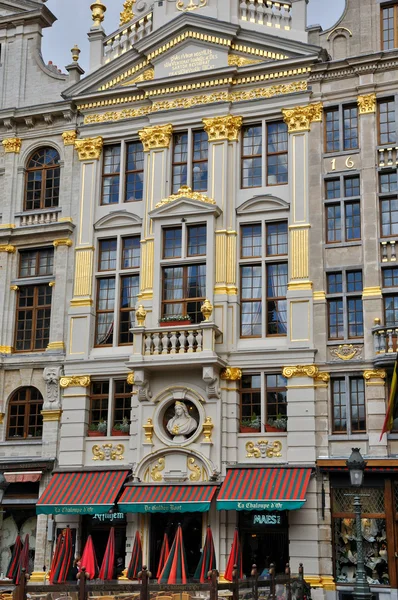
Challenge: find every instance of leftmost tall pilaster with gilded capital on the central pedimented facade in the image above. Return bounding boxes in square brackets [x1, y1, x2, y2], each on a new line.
[68, 137, 103, 358]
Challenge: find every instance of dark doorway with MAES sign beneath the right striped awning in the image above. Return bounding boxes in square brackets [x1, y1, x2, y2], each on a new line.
[239, 511, 289, 576]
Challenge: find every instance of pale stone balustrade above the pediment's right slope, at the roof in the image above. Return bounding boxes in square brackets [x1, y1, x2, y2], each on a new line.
[239, 0, 292, 29]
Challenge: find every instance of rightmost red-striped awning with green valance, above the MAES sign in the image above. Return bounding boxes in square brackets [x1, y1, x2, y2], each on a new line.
[217, 468, 311, 510]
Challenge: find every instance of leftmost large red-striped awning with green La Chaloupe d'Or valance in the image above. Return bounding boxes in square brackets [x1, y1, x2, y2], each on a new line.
[36, 471, 129, 515]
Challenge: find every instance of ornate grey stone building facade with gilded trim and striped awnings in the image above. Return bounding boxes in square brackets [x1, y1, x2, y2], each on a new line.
[0, 0, 398, 597]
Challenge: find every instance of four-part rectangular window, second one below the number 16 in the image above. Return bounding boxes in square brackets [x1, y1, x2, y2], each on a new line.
[327, 271, 363, 340]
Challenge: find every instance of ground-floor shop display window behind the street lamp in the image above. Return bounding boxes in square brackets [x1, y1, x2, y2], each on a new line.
[332, 487, 393, 585]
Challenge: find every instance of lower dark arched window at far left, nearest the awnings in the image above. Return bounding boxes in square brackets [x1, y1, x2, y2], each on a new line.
[7, 387, 43, 439]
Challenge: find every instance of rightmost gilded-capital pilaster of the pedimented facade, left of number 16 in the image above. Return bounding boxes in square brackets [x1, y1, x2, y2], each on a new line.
[282, 103, 322, 345]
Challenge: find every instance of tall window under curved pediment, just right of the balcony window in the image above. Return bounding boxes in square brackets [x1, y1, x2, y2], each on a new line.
[240, 221, 288, 338]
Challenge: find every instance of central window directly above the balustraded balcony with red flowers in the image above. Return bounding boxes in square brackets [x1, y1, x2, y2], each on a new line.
[162, 224, 207, 323]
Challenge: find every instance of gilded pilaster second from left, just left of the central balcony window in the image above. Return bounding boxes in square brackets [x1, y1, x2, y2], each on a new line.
[138, 124, 173, 301]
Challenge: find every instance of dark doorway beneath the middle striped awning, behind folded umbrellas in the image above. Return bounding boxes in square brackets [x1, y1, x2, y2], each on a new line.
[150, 512, 202, 577]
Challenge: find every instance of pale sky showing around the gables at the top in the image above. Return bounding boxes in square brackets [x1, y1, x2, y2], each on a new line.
[42, 0, 345, 71]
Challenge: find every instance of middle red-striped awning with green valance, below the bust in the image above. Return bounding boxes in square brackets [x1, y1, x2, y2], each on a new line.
[118, 484, 217, 513]
